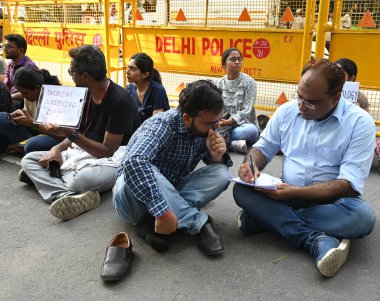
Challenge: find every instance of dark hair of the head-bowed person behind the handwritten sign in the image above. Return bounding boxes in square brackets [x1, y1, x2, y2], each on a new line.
[13, 67, 61, 89]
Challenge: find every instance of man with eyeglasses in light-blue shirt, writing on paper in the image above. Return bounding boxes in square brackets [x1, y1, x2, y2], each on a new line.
[233, 60, 376, 277]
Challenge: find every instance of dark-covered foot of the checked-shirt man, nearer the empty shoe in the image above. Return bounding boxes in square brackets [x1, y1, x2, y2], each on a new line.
[136, 215, 170, 253]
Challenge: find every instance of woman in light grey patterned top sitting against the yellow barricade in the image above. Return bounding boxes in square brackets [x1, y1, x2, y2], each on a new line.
[218, 48, 259, 153]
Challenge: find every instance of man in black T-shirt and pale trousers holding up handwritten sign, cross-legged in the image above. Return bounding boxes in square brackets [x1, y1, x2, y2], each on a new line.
[21, 46, 140, 220]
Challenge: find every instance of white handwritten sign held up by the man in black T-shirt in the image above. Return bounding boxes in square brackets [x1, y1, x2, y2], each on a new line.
[34, 85, 87, 128]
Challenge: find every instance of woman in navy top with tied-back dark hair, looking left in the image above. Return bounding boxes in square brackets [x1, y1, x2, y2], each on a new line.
[127, 53, 170, 123]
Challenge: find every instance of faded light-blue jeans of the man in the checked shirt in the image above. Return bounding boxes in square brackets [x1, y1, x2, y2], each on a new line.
[113, 163, 230, 235]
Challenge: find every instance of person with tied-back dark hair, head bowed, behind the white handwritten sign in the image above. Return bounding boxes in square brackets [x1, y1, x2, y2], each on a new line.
[0, 67, 62, 154]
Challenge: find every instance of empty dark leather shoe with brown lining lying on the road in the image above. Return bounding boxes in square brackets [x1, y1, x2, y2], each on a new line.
[100, 232, 133, 281]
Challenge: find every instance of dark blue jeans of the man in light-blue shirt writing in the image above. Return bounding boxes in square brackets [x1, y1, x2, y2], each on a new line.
[233, 184, 376, 250]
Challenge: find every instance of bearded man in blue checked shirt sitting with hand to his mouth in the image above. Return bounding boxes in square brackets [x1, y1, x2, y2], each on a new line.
[113, 80, 232, 255]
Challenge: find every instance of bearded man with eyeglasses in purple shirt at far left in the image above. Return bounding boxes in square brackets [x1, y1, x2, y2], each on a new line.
[4, 34, 38, 109]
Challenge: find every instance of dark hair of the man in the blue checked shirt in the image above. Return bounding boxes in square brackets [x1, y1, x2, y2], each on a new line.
[178, 80, 224, 117]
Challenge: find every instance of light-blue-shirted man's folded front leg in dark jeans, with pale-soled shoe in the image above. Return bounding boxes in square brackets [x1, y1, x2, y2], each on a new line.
[233, 184, 349, 277]
